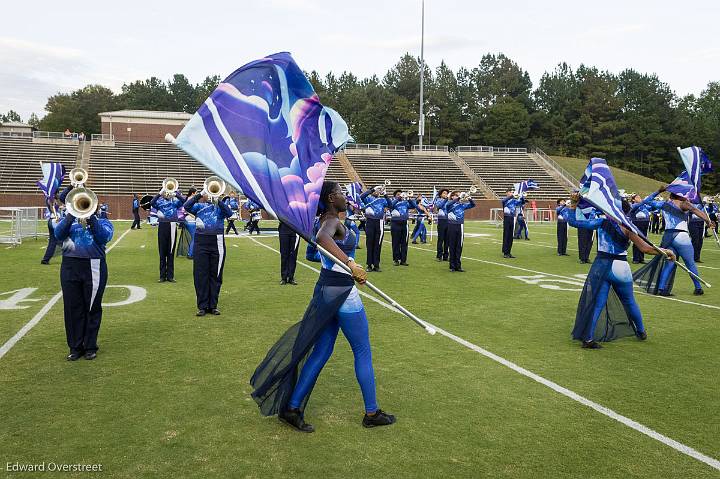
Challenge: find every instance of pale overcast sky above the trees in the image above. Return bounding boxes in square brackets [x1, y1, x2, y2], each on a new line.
[0, 0, 720, 120]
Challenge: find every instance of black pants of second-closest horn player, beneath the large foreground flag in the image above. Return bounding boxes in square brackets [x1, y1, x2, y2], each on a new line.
[193, 234, 225, 311]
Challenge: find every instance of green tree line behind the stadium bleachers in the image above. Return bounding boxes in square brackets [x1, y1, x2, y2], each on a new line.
[7, 54, 720, 188]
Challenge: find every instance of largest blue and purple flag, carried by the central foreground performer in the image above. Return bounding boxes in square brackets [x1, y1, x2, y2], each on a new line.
[173, 52, 351, 238]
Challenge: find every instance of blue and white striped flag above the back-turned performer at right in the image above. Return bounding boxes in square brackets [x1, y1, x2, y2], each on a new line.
[580, 158, 640, 234]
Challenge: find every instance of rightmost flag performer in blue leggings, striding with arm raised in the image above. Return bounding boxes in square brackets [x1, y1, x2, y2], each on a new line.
[634, 186, 715, 296]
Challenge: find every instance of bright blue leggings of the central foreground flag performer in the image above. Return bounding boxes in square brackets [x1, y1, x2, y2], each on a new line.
[289, 306, 378, 412]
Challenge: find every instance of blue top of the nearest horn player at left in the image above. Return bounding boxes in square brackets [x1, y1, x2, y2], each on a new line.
[55, 215, 113, 259]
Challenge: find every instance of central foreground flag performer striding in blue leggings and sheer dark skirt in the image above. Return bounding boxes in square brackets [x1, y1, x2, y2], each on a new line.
[250, 181, 395, 433]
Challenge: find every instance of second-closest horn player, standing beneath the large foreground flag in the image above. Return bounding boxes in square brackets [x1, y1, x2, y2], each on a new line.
[183, 190, 232, 316]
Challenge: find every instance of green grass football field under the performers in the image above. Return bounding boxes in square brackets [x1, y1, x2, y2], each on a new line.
[0, 222, 720, 479]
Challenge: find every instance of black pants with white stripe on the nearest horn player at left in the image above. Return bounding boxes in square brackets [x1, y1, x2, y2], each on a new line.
[60, 256, 107, 353]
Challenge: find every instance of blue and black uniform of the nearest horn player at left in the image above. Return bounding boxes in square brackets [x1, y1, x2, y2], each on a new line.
[55, 210, 113, 361]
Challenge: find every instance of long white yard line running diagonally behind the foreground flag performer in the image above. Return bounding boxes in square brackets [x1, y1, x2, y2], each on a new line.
[253, 240, 720, 471]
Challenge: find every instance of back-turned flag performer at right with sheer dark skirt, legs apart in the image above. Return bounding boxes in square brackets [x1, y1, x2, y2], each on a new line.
[568, 193, 674, 349]
